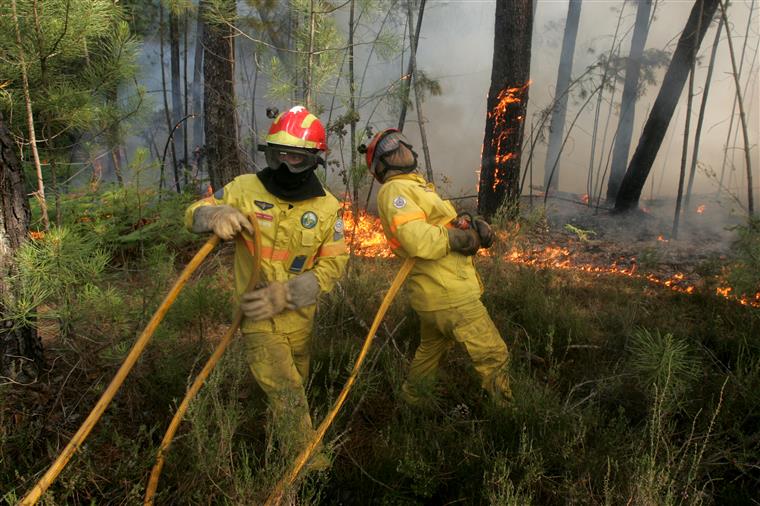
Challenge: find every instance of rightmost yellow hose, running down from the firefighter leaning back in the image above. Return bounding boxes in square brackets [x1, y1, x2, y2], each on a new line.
[265, 258, 415, 506]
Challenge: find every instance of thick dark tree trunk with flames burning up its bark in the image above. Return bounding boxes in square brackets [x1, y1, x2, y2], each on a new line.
[478, 0, 533, 218]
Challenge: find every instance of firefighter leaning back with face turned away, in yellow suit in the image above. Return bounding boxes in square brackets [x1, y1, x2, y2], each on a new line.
[364, 128, 512, 405]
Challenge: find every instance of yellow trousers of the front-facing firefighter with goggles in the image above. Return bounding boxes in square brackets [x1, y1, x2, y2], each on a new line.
[243, 328, 314, 457]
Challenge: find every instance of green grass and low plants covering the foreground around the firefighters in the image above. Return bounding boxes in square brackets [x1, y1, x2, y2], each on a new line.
[0, 189, 760, 505]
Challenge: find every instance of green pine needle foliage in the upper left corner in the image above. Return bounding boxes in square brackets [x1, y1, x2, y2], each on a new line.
[0, 0, 142, 174]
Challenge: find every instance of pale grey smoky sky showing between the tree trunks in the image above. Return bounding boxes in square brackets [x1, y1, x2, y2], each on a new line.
[127, 0, 760, 210]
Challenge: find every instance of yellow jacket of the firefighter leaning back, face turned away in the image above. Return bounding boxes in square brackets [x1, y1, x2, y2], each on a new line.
[377, 173, 483, 311]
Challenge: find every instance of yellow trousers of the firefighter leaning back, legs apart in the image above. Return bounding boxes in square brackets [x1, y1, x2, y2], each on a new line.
[401, 300, 512, 405]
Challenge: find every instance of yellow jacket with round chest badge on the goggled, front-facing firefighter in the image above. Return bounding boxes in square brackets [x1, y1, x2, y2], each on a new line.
[185, 174, 348, 333]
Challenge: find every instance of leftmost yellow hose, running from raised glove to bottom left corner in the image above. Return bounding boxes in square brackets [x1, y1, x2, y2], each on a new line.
[19, 235, 219, 506]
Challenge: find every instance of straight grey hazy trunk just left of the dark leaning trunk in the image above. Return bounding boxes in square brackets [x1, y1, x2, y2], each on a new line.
[607, 0, 652, 201]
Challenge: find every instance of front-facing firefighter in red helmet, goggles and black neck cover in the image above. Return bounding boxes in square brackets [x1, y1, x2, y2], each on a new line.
[185, 106, 348, 469]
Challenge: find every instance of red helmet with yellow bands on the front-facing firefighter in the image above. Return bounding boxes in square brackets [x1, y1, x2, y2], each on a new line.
[266, 105, 327, 151]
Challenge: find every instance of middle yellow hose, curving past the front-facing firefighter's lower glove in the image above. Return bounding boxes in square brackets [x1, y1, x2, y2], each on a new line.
[144, 219, 261, 506]
